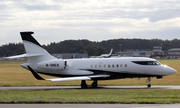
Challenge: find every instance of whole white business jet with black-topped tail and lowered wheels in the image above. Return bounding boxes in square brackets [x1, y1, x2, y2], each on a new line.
[9, 32, 176, 88]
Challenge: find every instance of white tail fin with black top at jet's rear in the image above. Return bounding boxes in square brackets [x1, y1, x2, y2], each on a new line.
[20, 32, 56, 68]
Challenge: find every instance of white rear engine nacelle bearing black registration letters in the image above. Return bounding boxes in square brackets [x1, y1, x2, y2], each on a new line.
[38, 59, 65, 71]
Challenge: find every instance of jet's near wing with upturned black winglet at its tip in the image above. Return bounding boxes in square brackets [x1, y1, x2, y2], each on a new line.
[28, 66, 110, 81]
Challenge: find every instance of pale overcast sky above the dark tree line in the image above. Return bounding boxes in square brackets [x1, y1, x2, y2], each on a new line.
[0, 0, 180, 45]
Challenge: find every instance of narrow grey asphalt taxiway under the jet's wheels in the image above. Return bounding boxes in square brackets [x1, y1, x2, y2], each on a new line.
[0, 85, 180, 90]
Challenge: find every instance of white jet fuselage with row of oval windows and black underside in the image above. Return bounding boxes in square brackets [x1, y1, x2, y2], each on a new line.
[22, 57, 176, 77]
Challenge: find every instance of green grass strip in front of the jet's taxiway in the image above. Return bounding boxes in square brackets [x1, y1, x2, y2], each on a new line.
[0, 89, 180, 104]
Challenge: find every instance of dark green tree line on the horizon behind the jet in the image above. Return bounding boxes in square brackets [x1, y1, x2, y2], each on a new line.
[0, 39, 180, 57]
